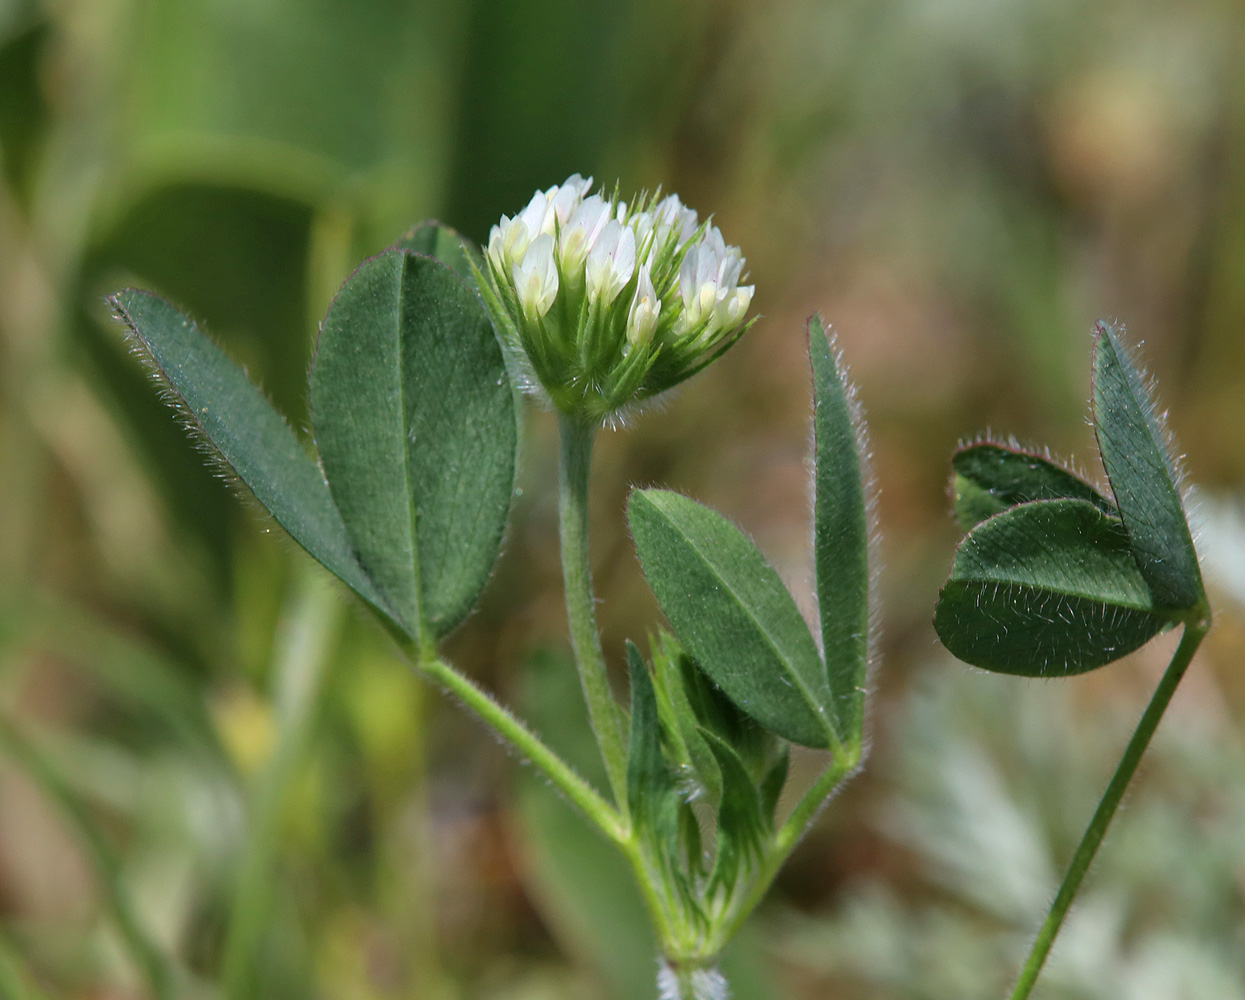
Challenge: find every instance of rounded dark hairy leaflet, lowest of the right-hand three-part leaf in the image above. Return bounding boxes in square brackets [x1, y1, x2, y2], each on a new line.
[934, 499, 1172, 677]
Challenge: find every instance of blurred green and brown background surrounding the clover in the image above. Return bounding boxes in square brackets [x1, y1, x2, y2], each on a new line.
[0, 0, 1245, 1000]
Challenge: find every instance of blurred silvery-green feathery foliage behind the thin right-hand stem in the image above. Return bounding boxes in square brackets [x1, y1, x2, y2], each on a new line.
[771, 647, 1245, 1000]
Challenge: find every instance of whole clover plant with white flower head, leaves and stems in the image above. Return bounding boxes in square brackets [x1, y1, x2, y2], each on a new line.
[112, 174, 870, 998]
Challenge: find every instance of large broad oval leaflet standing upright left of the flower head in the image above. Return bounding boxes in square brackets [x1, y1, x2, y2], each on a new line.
[311, 250, 518, 638]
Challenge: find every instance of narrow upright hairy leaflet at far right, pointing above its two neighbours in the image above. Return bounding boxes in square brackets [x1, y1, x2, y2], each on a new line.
[1093, 323, 1206, 610]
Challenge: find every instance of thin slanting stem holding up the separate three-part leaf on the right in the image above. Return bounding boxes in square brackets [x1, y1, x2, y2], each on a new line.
[1011, 620, 1208, 1000]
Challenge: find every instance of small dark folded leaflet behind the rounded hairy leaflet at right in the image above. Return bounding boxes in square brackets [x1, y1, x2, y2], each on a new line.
[951, 441, 1116, 531]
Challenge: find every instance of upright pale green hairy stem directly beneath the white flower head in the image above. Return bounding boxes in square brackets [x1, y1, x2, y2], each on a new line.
[558, 413, 626, 816]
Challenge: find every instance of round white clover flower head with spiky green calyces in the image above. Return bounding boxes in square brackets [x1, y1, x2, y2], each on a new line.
[477, 174, 753, 422]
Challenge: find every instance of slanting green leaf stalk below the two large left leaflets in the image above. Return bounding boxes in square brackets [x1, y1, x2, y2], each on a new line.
[408, 650, 630, 844]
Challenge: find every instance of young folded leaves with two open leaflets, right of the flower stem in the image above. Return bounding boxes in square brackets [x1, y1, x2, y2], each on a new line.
[627, 318, 870, 953]
